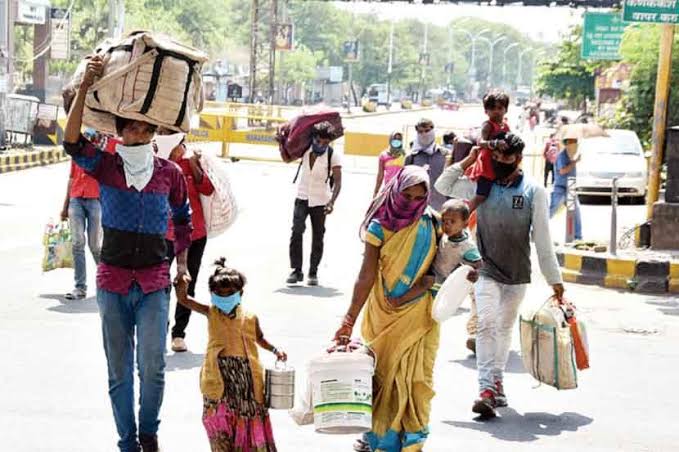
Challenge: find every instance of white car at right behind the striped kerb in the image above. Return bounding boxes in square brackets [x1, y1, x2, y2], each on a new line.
[576, 129, 648, 199]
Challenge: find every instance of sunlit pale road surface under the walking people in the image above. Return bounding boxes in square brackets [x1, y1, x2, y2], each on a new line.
[0, 154, 679, 452]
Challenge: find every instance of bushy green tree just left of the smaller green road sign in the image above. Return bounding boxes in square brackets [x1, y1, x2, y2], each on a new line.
[536, 26, 605, 108]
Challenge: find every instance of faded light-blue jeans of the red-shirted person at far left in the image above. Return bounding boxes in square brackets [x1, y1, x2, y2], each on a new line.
[68, 198, 102, 290]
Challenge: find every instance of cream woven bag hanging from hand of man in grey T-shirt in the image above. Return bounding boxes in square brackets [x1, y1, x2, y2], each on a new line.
[519, 298, 589, 389]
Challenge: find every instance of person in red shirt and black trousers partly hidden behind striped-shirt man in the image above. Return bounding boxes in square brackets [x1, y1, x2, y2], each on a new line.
[155, 128, 215, 353]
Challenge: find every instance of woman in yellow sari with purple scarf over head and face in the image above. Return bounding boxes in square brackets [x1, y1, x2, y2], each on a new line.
[335, 166, 439, 452]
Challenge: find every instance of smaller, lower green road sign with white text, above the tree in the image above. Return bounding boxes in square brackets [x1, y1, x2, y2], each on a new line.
[582, 12, 626, 60]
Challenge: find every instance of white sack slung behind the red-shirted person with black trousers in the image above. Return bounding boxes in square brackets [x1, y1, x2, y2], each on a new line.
[195, 150, 238, 238]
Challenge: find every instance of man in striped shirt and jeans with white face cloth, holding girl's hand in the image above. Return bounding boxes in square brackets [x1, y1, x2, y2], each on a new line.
[64, 55, 192, 452]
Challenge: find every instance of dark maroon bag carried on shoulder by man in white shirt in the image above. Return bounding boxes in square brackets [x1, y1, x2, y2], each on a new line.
[276, 110, 344, 163]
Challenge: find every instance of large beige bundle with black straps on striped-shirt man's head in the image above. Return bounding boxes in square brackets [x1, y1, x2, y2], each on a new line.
[72, 32, 208, 134]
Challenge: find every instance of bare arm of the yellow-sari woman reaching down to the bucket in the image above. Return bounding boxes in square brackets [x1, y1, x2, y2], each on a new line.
[335, 243, 380, 345]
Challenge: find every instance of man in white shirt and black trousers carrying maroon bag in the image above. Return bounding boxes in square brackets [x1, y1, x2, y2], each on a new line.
[287, 121, 342, 286]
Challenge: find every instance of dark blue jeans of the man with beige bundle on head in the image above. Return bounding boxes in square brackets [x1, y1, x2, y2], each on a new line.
[97, 283, 170, 452]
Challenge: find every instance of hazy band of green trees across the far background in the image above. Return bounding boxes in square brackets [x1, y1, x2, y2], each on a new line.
[18, 0, 538, 100]
